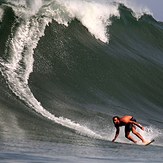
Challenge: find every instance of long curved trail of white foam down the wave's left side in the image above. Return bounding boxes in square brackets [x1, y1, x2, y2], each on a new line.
[1, 1, 118, 138]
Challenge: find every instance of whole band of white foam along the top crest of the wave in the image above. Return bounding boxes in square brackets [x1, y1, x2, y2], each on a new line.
[3, 0, 152, 43]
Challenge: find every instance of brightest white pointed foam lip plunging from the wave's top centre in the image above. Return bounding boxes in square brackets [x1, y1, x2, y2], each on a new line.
[54, 0, 119, 42]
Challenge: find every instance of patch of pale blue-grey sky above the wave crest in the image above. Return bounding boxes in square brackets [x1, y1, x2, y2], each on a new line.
[133, 0, 163, 22]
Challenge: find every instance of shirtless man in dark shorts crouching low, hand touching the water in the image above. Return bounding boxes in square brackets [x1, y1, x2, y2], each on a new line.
[112, 115, 147, 144]
